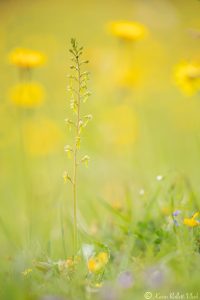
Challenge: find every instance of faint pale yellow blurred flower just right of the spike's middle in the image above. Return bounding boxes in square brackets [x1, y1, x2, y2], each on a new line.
[105, 104, 138, 146]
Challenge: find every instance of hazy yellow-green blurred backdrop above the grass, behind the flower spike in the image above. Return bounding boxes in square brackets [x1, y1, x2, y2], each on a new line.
[0, 0, 200, 251]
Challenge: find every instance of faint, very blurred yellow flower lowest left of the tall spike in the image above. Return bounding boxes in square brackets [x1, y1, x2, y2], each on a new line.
[24, 119, 62, 156]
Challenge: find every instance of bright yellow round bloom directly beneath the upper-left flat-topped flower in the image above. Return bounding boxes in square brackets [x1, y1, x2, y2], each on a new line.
[10, 82, 45, 108]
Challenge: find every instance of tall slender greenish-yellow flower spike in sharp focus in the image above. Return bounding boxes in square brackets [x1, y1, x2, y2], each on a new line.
[64, 39, 92, 256]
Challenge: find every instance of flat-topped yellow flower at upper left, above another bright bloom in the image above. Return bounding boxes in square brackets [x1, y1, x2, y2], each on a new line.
[9, 48, 46, 68]
